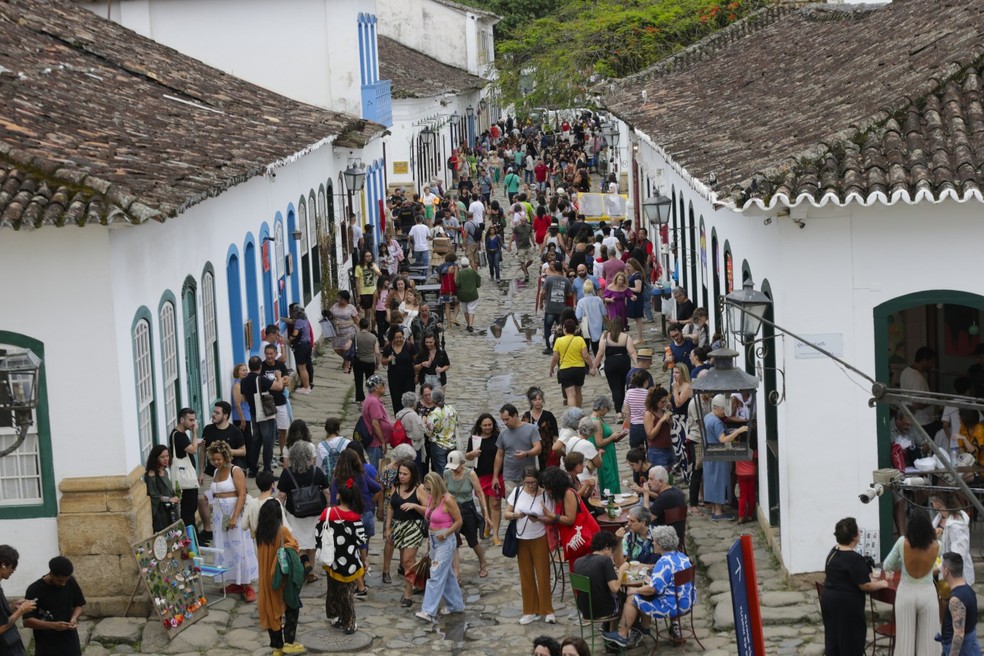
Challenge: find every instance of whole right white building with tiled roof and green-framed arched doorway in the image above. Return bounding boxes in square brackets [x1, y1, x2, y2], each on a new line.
[606, 0, 984, 574]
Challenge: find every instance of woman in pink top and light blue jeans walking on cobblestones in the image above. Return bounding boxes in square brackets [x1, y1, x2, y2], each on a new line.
[416, 472, 465, 622]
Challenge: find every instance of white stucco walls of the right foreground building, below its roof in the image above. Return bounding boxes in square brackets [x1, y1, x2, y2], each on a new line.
[629, 129, 981, 573]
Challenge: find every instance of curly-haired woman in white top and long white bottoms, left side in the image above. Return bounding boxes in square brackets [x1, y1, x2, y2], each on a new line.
[206, 440, 258, 603]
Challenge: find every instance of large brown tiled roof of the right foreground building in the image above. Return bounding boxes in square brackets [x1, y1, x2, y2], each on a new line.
[608, 0, 984, 207]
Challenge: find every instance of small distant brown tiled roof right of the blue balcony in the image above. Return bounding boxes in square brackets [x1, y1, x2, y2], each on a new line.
[378, 36, 486, 99]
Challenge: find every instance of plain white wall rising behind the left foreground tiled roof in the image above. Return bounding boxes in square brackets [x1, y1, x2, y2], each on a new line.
[83, 0, 375, 116]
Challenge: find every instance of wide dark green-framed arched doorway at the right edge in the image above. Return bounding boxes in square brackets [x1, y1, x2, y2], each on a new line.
[873, 289, 984, 553]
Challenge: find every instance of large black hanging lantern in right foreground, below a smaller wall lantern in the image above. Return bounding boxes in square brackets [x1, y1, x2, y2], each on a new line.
[693, 348, 759, 461]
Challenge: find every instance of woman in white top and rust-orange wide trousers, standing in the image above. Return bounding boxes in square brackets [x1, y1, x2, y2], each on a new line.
[503, 467, 557, 625]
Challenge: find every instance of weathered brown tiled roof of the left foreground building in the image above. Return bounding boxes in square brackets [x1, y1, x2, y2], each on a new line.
[0, 0, 384, 228]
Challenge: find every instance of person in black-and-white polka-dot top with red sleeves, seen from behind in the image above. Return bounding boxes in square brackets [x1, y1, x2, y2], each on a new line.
[318, 478, 366, 635]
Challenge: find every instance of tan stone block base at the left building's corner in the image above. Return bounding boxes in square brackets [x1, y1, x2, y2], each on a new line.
[58, 467, 153, 617]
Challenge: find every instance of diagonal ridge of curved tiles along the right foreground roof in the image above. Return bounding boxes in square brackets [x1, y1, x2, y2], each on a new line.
[731, 44, 984, 207]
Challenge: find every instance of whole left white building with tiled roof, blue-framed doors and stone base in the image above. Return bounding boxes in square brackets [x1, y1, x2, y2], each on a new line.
[0, 0, 384, 615]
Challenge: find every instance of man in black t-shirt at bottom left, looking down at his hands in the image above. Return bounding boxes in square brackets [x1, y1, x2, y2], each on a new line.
[24, 556, 85, 656]
